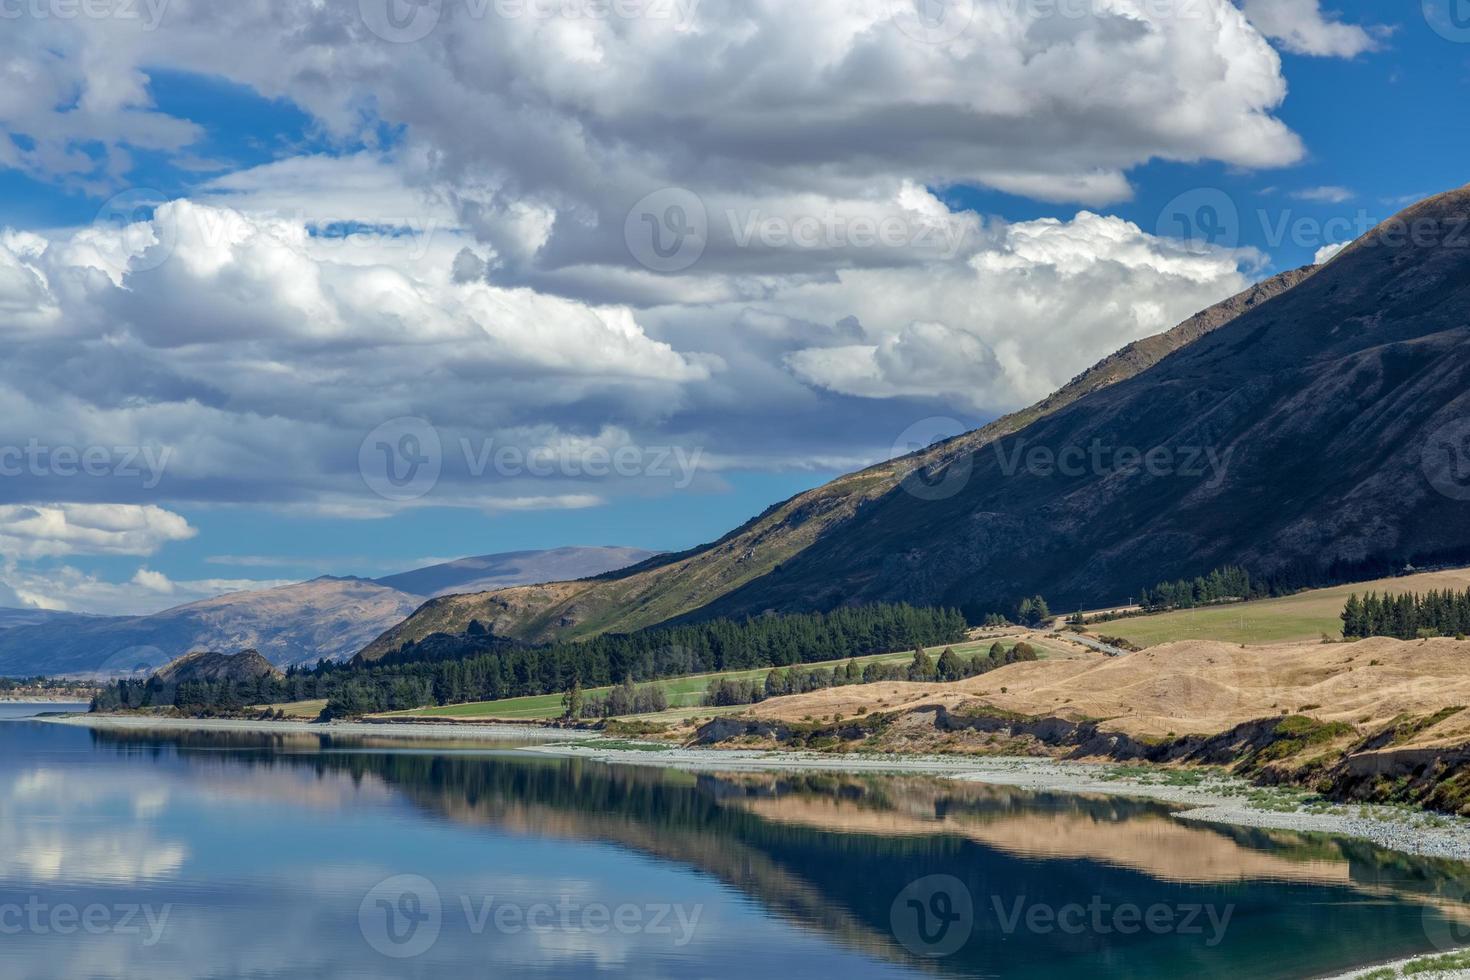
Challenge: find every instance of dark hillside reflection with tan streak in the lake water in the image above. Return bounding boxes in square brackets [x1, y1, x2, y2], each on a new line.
[88, 732, 1470, 977]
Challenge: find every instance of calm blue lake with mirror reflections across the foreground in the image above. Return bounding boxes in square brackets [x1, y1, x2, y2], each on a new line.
[0, 720, 1470, 980]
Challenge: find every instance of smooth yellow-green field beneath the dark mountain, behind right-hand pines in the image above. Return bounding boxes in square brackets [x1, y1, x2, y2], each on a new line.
[1088, 569, 1470, 646]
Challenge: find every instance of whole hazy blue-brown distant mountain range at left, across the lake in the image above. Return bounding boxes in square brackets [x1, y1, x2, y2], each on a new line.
[0, 548, 653, 677]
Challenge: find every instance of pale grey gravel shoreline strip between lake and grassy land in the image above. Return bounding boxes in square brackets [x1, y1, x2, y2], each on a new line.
[37, 714, 1470, 862]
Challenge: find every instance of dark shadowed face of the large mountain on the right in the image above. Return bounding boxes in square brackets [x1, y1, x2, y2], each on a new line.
[701, 188, 1470, 616]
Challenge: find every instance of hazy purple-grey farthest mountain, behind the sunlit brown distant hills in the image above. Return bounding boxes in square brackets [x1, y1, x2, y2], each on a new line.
[376, 548, 654, 597]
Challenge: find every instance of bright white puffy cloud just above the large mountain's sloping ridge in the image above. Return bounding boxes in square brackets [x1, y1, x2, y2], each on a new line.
[784, 212, 1248, 413]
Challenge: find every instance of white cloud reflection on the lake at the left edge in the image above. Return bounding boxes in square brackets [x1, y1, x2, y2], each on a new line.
[0, 768, 188, 884]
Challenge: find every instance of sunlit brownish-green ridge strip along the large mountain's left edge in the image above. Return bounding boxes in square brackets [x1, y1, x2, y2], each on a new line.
[360, 266, 1316, 660]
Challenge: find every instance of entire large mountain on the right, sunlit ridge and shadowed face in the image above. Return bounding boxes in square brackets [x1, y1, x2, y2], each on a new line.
[363, 188, 1470, 660]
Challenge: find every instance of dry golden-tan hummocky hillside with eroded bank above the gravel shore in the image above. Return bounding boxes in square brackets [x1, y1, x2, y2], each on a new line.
[700, 638, 1470, 814]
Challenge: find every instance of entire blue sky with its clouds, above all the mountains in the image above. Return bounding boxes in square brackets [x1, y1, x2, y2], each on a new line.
[0, 0, 1470, 611]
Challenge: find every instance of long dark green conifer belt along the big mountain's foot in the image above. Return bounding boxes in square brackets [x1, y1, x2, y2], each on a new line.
[93, 604, 967, 717]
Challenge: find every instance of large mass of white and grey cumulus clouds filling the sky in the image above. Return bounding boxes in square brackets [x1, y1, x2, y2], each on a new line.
[0, 0, 1323, 614]
